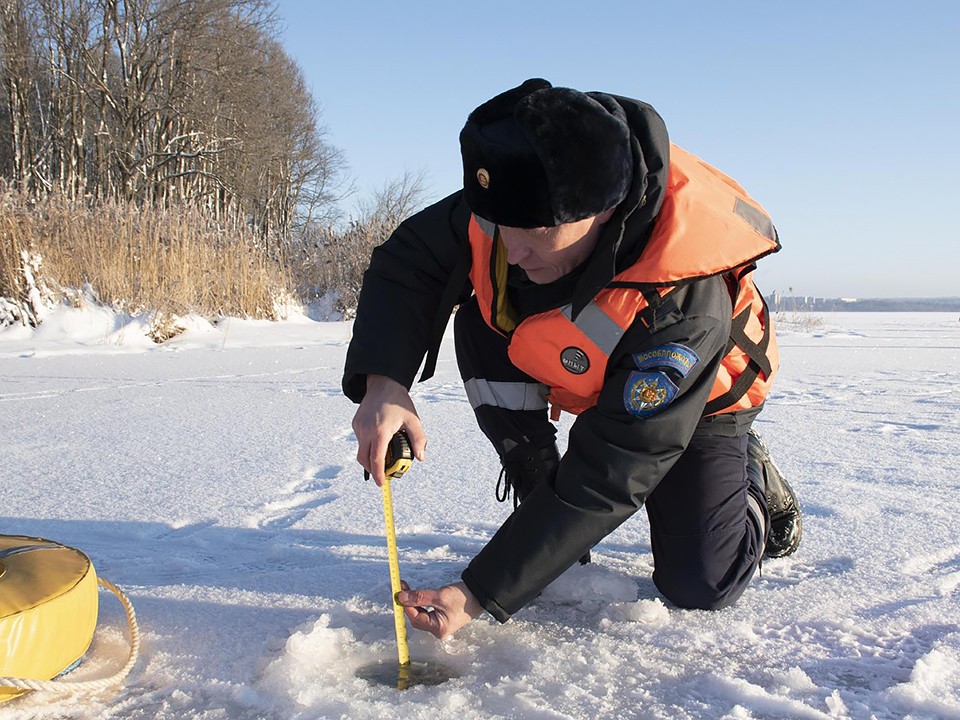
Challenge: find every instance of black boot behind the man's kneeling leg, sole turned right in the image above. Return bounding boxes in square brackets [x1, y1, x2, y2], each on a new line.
[747, 430, 803, 558]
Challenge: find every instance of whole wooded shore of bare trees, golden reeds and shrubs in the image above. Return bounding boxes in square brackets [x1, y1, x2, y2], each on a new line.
[0, 0, 423, 338]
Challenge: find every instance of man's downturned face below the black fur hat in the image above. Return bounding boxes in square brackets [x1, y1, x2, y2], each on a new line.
[500, 209, 613, 285]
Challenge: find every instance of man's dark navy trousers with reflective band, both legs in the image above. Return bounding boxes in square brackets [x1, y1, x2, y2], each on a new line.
[454, 298, 768, 610]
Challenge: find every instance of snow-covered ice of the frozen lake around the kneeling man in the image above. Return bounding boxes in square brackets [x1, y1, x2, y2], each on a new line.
[0, 307, 960, 720]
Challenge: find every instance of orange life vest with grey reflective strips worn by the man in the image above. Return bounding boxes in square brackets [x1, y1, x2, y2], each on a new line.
[469, 145, 779, 418]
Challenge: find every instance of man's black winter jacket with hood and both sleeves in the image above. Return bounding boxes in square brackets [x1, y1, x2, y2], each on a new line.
[343, 97, 758, 621]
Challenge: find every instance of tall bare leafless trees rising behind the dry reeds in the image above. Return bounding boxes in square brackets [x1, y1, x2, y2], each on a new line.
[0, 0, 343, 238]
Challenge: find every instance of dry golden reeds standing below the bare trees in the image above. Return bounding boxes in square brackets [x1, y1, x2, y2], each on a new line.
[0, 186, 289, 334]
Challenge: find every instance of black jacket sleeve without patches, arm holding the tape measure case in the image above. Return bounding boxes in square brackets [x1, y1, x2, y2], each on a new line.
[343, 192, 471, 402]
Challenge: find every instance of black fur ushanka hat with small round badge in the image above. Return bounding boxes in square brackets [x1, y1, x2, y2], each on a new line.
[460, 79, 633, 228]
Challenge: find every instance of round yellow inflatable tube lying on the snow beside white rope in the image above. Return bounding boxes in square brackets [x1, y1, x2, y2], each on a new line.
[0, 535, 98, 702]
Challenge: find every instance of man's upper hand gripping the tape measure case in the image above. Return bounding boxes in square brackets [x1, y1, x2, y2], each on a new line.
[353, 375, 427, 485]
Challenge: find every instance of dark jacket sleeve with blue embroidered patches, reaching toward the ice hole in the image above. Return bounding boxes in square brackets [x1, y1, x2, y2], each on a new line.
[462, 278, 732, 622]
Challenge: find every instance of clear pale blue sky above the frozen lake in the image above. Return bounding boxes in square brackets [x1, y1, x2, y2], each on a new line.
[277, 0, 960, 297]
